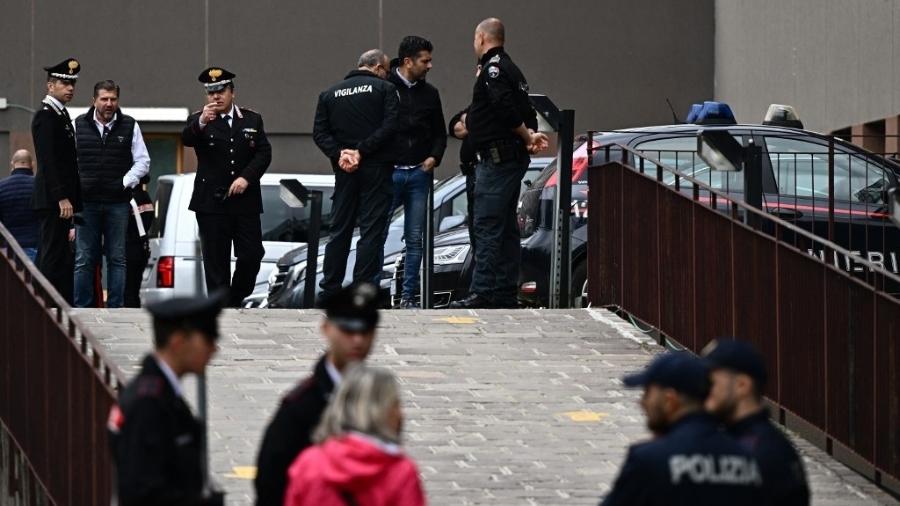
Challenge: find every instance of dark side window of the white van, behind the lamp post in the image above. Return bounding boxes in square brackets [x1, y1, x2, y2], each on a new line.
[260, 185, 334, 242]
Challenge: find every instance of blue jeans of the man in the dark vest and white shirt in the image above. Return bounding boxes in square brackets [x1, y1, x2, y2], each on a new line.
[75, 202, 131, 307]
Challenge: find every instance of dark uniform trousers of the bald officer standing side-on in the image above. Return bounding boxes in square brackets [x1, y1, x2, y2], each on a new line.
[469, 156, 530, 307]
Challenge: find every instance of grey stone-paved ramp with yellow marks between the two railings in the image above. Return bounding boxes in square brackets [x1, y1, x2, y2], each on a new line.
[76, 309, 896, 506]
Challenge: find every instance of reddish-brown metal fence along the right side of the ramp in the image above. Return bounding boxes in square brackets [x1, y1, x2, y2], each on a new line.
[588, 142, 900, 493]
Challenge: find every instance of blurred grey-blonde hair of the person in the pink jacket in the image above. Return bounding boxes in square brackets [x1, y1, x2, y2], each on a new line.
[313, 364, 400, 443]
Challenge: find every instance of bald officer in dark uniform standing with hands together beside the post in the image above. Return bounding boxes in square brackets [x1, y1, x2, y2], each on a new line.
[450, 18, 547, 308]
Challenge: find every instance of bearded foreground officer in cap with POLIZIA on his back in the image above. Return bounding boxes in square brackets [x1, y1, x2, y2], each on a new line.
[602, 352, 764, 506]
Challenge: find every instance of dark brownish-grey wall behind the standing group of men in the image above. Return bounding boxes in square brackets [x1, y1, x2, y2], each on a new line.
[0, 0, 714, 178]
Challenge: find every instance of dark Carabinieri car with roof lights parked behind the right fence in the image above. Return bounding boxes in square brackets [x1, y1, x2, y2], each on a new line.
[519, 104, 900, 306]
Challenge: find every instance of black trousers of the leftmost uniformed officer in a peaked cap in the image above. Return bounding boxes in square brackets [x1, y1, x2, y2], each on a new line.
[37, 209, 75, 305]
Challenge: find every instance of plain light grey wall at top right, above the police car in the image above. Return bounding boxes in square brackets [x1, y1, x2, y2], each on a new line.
[715, 0, 900, 132]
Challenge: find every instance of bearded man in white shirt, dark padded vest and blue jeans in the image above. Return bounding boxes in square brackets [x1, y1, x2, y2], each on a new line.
[74, 80, 150, 308]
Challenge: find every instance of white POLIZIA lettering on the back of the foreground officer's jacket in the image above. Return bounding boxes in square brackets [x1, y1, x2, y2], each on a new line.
[669, 455, 762, 485]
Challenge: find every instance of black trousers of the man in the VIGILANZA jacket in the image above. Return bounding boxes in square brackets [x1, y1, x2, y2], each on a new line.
[319, 163, 394, 297]
